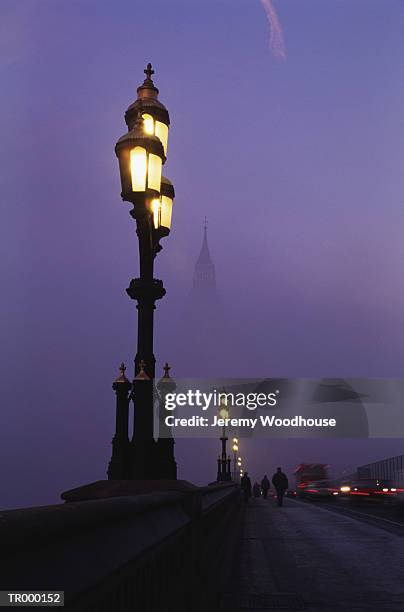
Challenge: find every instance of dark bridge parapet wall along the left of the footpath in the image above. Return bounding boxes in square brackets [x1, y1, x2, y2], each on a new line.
[0, 484, 242, 612]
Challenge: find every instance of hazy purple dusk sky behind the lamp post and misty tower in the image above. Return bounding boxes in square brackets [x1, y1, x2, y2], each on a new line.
[0, 0, 404, 508]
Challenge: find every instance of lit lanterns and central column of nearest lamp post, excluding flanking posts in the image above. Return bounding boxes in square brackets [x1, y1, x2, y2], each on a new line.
[115, 64, 175, 478]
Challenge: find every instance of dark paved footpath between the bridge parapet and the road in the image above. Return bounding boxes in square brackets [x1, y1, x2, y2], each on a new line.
[238, 499, 404, 612]
